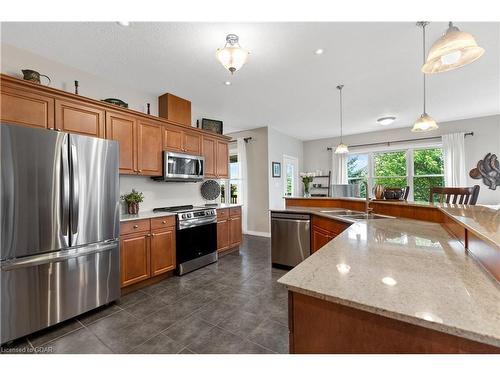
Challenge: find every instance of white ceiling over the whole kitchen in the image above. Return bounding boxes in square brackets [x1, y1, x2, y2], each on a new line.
[2, 22, 500, 140]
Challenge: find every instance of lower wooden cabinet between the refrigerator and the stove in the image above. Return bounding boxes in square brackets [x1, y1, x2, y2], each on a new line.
[120, 216, 176, 287]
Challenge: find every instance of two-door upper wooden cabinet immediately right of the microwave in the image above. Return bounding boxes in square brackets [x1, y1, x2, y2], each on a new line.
[202, 135, 229, 178]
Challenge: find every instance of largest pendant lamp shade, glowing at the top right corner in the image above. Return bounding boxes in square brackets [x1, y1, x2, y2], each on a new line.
[422, 22, 484, 74]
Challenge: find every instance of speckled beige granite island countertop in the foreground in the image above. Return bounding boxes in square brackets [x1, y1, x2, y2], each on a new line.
[278, 216, 500, 346]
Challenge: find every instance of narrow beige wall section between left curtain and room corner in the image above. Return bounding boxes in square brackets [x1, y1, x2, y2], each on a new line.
[228, 127, 270, 235]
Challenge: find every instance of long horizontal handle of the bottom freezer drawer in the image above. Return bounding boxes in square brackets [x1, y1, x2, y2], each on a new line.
[0, 240, 118, 271]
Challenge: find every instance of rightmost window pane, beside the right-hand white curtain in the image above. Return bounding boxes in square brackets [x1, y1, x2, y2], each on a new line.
[413, 148, 444, 201]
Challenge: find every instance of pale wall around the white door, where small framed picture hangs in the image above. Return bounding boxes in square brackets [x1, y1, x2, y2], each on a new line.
[267, 128, 303, 209]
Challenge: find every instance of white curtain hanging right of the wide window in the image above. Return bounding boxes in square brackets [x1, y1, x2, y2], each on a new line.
[442, 133, 467, 187]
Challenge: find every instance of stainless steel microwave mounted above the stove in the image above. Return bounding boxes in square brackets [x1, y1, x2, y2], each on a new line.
[153, 151, 205, 182]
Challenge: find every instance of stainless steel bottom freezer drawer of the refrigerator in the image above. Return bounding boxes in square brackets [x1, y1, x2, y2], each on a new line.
[0, 241, 120, 343]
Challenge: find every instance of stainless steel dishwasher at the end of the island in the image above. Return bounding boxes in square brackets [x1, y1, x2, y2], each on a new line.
[271, 212, 311, 268]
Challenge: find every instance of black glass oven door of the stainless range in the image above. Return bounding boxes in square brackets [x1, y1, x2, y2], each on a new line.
[176, 223, 217, 265]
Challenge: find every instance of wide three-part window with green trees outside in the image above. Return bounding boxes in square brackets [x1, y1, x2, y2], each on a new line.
[347, 147, 444, 201]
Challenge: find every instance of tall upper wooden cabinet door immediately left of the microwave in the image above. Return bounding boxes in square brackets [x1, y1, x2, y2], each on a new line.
[137, 119, 163, 176]
